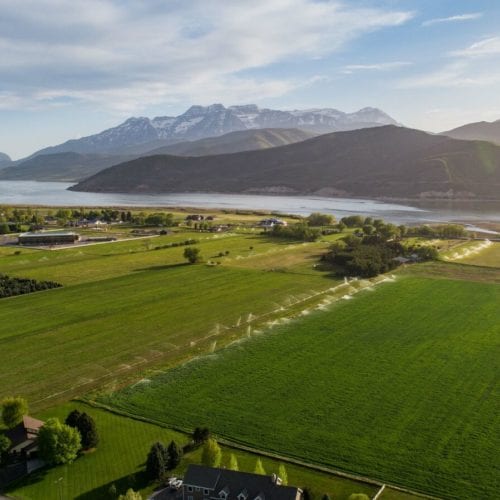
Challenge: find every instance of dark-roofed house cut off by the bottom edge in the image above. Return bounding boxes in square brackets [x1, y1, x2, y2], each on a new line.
[182, 464, 303, 500]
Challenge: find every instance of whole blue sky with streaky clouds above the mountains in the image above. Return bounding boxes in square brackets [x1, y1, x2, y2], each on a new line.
[0, 0, 500, 159]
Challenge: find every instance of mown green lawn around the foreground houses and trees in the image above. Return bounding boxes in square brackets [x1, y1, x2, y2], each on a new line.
[8, 403, 376, 500]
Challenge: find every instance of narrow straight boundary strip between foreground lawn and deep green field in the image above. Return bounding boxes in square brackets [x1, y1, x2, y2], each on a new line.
[75, 398, 441, 500]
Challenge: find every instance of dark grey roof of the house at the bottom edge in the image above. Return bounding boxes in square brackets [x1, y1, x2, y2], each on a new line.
[184, 464, 300, 500]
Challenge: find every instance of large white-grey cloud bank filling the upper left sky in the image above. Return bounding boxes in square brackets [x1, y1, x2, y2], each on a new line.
[0, 0, 413, 113]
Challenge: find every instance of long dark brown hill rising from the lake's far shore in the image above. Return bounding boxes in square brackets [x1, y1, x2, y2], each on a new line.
[71, 125, 500, 199]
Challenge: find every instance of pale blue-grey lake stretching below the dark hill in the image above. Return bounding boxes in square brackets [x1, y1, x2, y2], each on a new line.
[0, 181, 500, 225]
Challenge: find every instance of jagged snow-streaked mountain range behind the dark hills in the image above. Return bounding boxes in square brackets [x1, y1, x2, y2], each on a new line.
[24, 104, 396, 156]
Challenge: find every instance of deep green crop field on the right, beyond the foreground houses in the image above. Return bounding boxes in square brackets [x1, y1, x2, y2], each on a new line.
[100, 276, 500, 499]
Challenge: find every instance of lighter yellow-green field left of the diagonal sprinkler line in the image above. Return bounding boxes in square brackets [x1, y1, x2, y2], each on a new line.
[0, 233, 335, 408]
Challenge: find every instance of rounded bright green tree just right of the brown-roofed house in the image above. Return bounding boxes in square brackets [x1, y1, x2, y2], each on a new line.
[38, 418, 81, 464]
